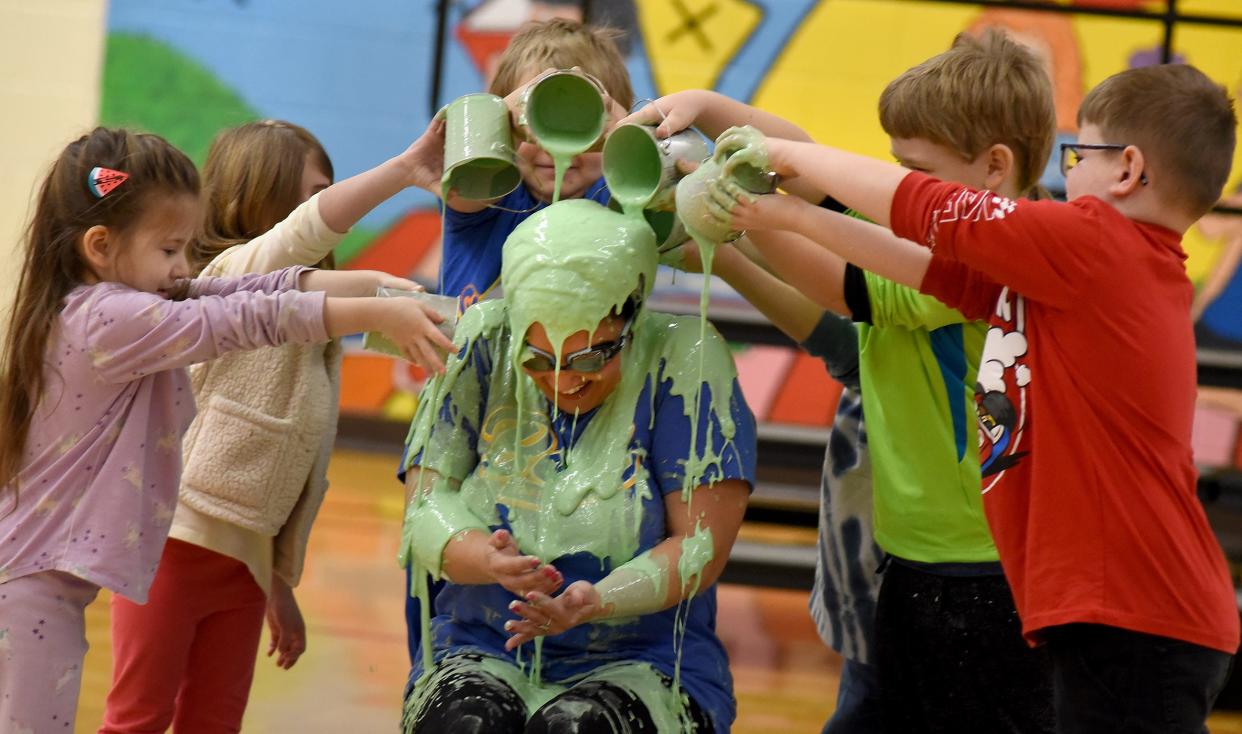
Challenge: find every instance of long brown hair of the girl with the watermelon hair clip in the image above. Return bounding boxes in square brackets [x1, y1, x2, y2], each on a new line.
[0, 128, 199, 501]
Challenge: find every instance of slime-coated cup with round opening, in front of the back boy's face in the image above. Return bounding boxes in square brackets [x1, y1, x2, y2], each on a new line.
[519, 70, 607, 155]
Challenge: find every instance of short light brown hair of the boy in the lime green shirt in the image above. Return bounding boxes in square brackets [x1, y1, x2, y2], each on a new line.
[879, 27, 1057, 191]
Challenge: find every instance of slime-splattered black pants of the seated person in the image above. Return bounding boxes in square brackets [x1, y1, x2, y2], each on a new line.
[411, 655, 713, 734]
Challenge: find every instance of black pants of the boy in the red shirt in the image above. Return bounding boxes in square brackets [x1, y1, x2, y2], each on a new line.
[1043, 625, 1233, 734]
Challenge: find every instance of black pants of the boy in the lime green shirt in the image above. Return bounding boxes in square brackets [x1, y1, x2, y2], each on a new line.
[876, 561, 1054, 734]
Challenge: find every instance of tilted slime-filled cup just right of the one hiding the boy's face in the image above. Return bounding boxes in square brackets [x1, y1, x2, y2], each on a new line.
[604, 123, 709, 210]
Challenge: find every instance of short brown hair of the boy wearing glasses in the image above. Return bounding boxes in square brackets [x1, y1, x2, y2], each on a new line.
[1078, 63, 1237, 219]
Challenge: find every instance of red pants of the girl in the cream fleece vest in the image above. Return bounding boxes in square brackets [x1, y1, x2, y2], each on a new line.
[99, 539, 267, 734]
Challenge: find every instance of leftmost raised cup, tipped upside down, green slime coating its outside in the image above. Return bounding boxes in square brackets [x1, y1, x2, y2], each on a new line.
[440, 93, 522, 200]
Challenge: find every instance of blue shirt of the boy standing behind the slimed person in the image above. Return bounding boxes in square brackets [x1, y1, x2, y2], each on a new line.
[440, 178, 609, 309]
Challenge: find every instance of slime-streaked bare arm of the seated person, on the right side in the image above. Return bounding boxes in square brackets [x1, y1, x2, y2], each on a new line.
[592, 479, 750, 618]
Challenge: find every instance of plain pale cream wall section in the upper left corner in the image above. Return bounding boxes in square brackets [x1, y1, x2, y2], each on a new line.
[0, 0, 107, 330]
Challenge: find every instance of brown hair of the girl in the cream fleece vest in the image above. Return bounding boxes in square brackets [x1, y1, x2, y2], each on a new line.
[191, 119, 333, 271]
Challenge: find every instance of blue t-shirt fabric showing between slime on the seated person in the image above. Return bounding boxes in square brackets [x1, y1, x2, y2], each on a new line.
[414, 303, 755, 732]
